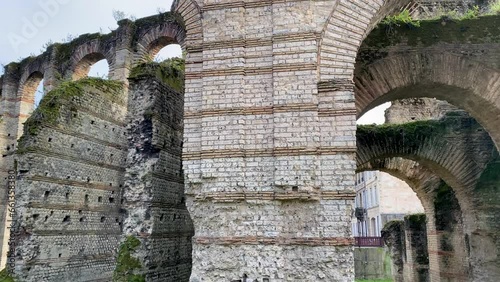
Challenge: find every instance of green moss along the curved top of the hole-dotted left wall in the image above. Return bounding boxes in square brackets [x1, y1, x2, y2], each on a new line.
[18, 77, 123, 144]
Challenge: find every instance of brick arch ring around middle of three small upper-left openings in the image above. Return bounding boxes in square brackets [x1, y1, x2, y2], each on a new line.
[68, 39, 115, 80]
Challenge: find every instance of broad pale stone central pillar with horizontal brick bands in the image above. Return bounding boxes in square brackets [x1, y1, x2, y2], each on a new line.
[178, 1, 364, 281]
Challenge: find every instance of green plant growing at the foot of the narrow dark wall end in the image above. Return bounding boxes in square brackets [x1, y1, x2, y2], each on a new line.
[113, 236, 146, 282]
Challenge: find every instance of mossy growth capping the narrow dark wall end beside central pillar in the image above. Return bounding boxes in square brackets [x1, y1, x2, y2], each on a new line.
[129, 58, 185, 93]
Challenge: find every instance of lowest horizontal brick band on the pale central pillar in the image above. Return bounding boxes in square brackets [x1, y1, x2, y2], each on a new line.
[193, 236, 354, 247]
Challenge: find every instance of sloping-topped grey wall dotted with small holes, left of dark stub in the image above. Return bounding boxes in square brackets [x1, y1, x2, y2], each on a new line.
[9, 80, 127, 281]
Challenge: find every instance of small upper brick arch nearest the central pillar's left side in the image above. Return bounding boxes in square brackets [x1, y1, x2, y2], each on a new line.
[136, 23, 186, 61]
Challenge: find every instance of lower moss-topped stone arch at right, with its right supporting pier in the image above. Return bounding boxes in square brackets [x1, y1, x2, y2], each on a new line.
[357, 116, 498, 278]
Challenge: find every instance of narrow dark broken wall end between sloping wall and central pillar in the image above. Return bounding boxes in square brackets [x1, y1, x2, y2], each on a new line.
[118, 77, 194, 282]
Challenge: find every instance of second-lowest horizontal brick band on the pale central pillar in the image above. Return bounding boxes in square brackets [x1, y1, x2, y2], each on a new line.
[195, 191, 356, 203]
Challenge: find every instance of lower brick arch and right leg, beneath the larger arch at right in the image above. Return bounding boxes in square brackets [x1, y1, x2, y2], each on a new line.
[357, 126, 494, 279]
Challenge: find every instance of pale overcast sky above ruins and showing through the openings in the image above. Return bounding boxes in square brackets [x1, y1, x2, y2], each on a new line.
[0, 0, 388, 123]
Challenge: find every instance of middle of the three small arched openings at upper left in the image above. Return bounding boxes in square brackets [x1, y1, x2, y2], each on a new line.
[72, 53, 109, 80]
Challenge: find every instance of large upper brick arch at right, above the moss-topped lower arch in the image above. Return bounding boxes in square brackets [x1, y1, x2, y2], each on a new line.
[354, 53, 500, 148]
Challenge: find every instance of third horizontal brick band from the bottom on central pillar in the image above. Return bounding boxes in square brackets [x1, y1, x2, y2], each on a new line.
[182, 147, 356, 160]
